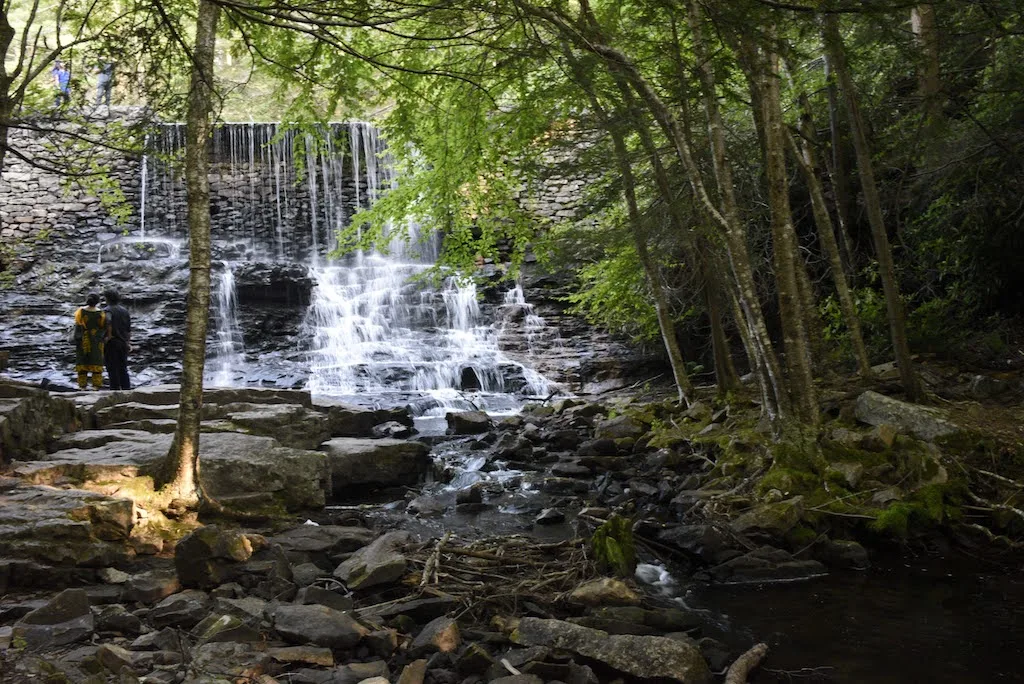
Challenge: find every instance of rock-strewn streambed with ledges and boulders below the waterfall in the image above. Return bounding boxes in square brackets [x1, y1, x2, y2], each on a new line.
[0, 376, 1022, 684]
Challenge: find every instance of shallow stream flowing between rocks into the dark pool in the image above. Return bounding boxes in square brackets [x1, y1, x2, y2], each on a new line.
[328, 417, 1024, 684]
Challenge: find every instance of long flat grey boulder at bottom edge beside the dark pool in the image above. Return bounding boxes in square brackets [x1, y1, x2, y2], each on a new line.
[512, 617, 711, 684]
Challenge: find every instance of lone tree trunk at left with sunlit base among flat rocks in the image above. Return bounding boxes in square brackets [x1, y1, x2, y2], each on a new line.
[164, 0, 220, 505]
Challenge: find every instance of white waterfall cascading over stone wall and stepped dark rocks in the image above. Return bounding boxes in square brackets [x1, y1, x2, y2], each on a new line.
[139, 123, 548, 410]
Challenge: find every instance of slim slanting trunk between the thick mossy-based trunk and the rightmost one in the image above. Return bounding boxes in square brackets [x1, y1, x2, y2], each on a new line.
[788, 112, 871, 378]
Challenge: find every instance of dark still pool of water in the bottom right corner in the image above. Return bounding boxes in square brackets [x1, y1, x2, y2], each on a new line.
[685, 561, 1024, 684]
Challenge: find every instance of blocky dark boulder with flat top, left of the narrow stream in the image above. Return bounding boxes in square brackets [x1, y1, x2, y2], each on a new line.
[323, 437, 430, 497]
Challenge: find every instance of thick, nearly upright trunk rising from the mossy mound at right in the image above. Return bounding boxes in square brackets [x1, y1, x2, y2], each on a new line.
[741, 38, 818, 425]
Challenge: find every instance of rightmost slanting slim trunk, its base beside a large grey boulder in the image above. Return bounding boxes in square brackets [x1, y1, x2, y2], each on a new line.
[822, 14, 922, 399]
